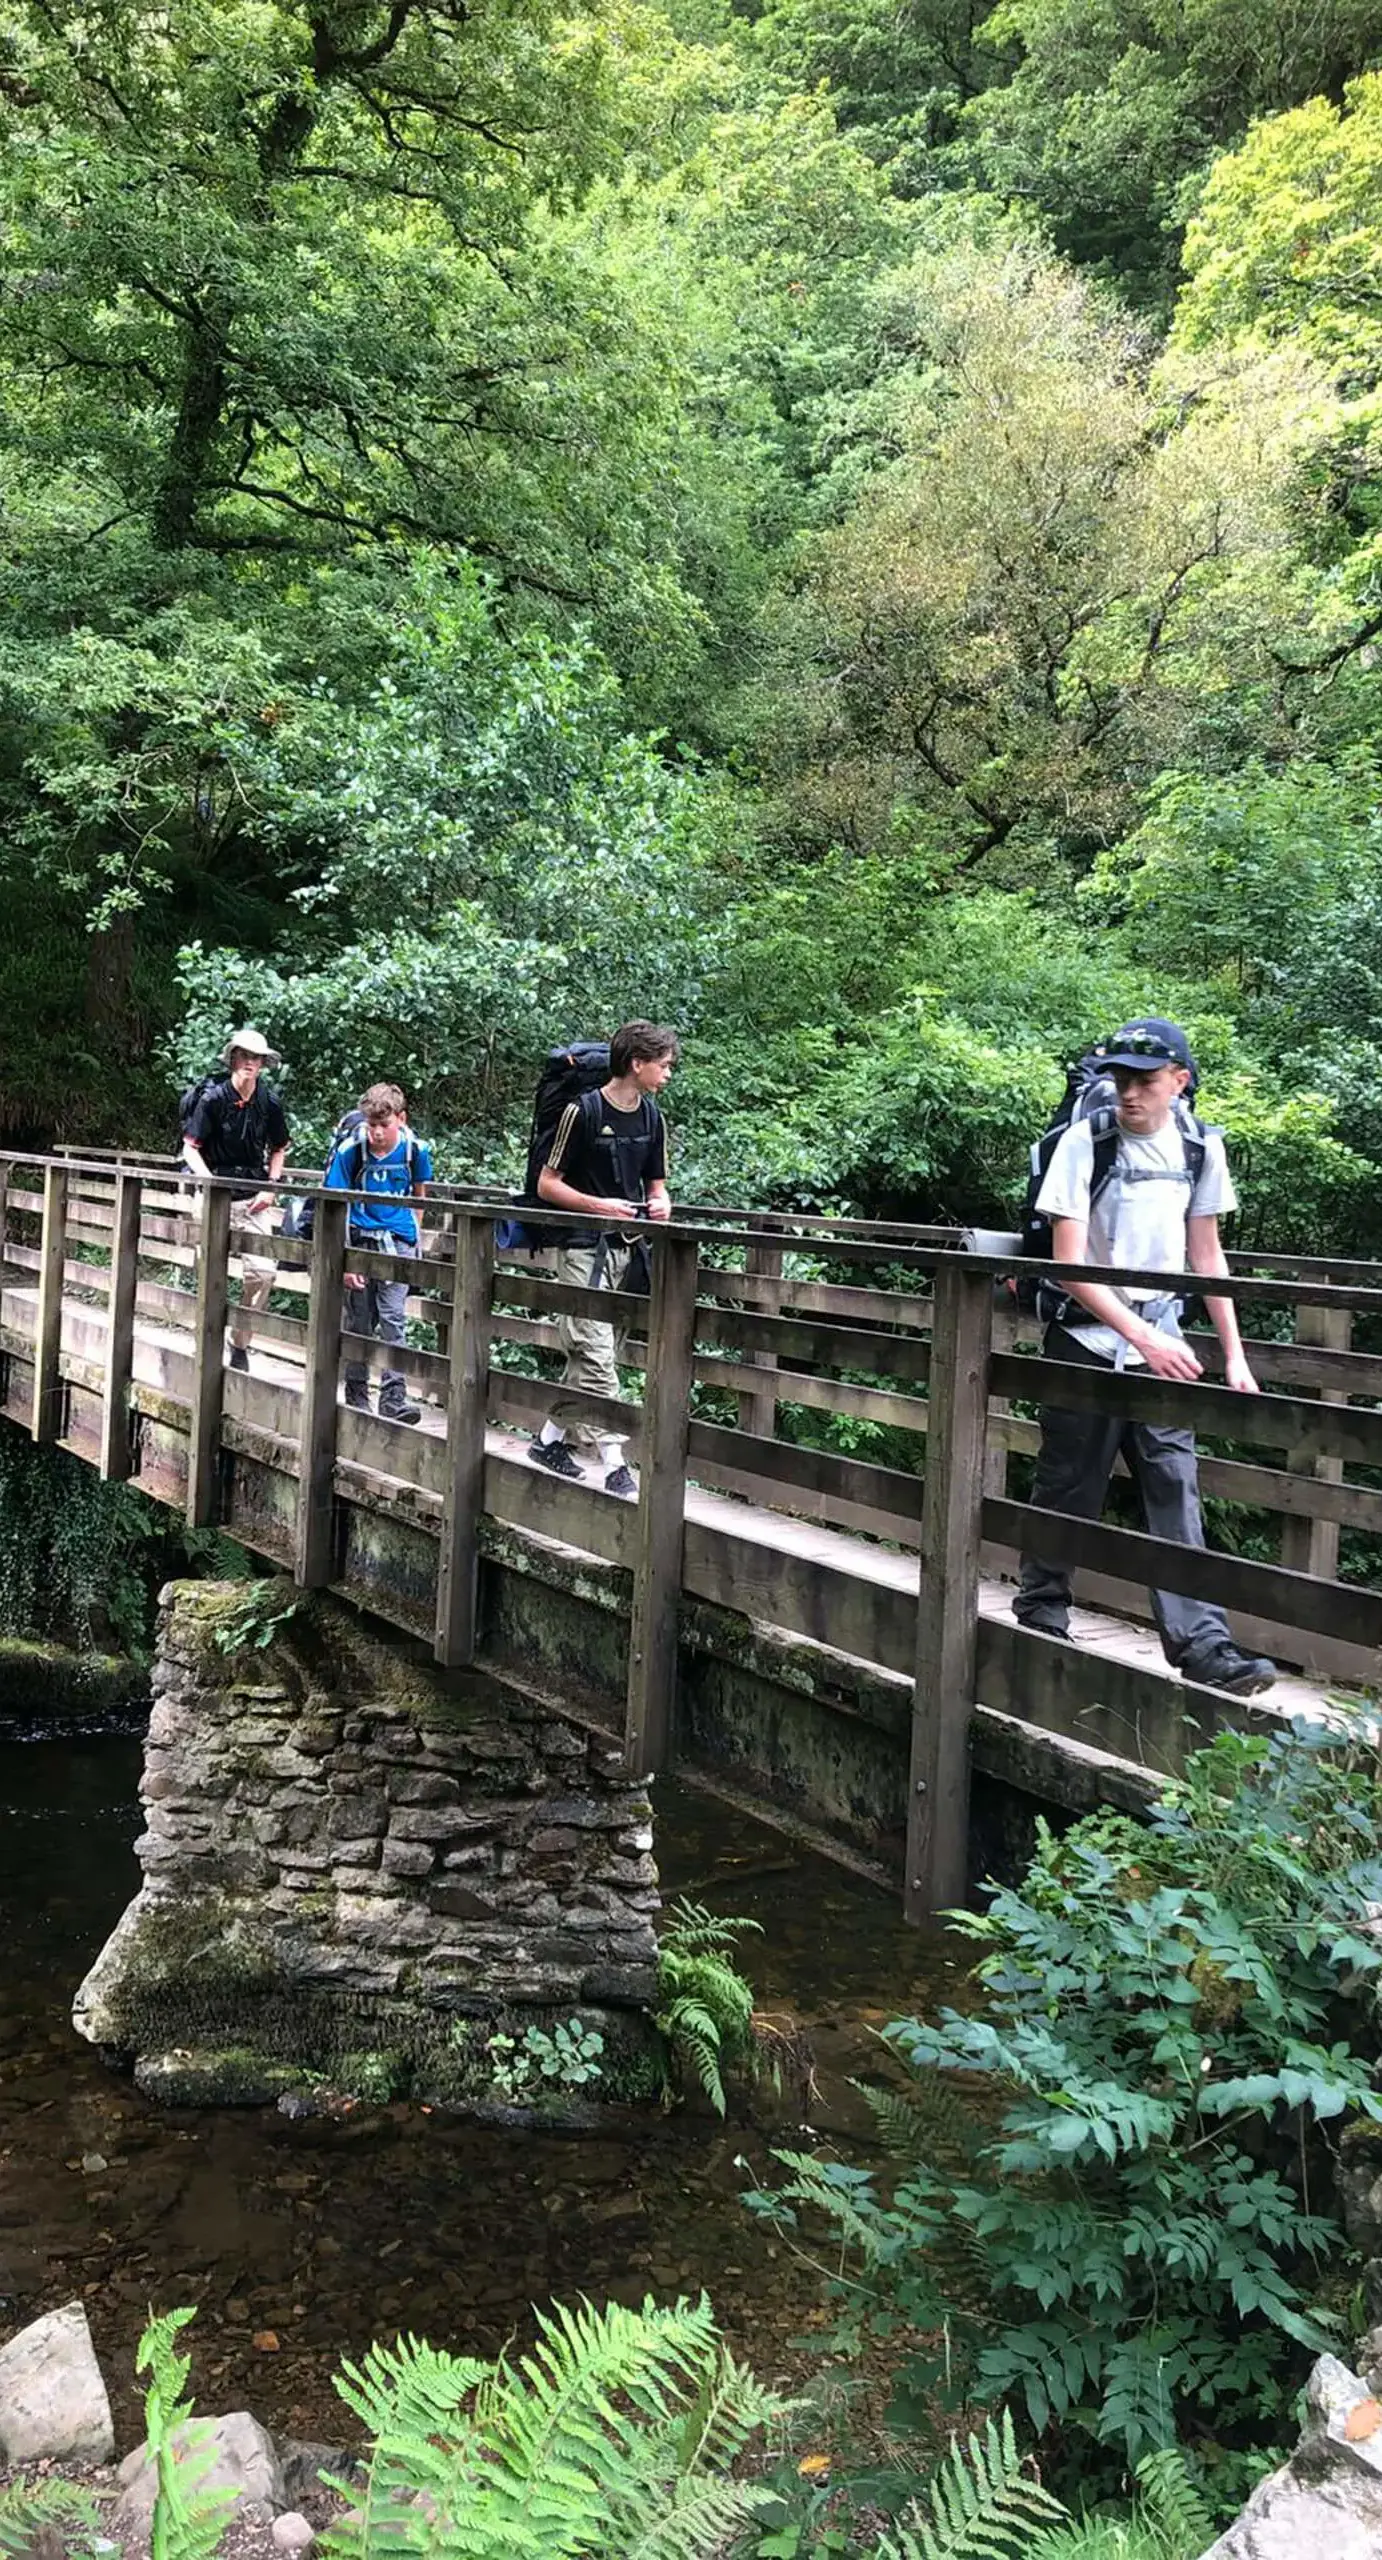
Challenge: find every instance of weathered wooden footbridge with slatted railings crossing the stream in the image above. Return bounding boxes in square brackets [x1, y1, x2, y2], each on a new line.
[0, 1155, 1382, 1917]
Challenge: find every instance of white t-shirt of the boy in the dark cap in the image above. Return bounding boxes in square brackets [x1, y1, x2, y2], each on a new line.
[1037, 1119, 1239, 1367]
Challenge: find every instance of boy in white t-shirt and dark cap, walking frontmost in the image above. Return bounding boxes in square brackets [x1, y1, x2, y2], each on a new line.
[1013, 1016, 1277, 1697]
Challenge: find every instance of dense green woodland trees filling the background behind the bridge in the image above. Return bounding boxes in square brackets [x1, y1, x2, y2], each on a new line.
[0, 0, 1382, 1252]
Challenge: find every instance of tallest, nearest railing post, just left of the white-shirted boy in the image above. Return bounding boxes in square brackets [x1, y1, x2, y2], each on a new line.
[903, 1257, 993, 1920]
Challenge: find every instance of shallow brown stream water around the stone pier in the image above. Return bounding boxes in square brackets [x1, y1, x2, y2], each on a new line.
[0, 1728, 960, 2450]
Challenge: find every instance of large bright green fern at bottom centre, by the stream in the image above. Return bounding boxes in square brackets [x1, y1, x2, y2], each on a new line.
[325, 2296, 783, 2560]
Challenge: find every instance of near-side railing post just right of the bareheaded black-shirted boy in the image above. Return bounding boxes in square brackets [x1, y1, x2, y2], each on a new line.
[624, 1231, 699, 1777]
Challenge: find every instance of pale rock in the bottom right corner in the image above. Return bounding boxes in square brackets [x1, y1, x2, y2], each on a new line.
[1203, 2355, 1382, 2560]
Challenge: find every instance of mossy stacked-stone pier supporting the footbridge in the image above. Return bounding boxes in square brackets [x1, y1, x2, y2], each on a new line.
[74, 1582, 660, 2115]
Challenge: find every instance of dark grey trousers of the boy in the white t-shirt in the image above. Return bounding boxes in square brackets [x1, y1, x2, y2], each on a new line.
[1013, 1324, 1234, 1669]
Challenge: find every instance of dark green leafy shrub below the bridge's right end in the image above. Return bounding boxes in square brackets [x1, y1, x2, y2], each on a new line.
[750, 1728, 1382, 2473]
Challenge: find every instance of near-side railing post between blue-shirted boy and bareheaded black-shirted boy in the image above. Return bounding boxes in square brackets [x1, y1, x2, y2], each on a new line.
[433, 1208, 494, 1672]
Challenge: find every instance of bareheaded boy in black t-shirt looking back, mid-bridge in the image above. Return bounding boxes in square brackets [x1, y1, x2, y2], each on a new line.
[527, 1021, 678, 1498]
